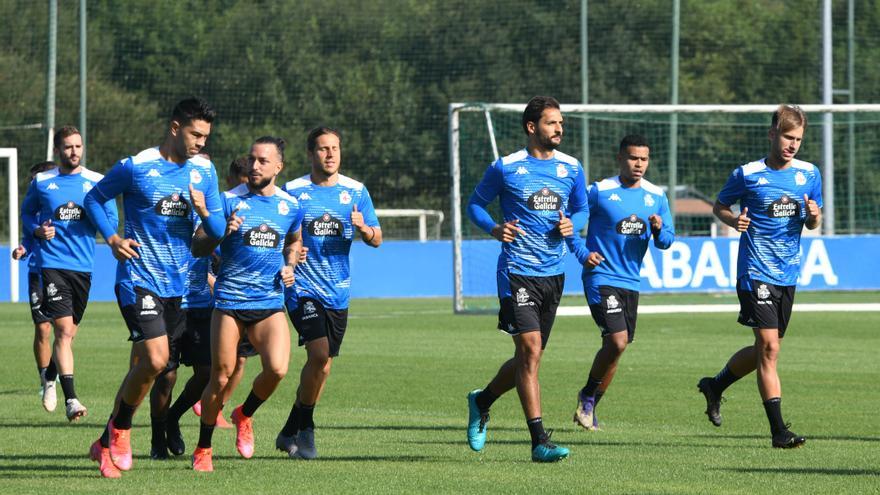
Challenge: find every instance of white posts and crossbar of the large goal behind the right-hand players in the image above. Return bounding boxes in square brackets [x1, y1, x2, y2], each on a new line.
[448, 103, 880, 313]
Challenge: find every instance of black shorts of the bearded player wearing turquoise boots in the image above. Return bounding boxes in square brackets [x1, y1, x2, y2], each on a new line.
[498, 273, 565, 349]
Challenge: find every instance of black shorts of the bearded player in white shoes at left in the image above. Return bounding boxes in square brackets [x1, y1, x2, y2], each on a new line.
[41, 268, 92, 325]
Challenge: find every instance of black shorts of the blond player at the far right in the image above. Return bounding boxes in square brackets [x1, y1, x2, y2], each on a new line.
[736, 280, 795, 339]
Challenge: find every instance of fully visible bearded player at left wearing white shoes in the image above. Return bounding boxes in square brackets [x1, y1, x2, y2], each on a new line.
[21, 126, 118, 421]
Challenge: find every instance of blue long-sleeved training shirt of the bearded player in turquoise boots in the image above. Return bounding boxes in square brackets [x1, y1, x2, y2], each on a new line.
[468, 149, 589, 280]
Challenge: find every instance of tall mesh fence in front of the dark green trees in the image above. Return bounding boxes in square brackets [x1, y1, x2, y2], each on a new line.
[0, 0, 880, 238]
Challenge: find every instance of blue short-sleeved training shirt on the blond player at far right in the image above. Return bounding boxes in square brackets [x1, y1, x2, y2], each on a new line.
[718, 158, 822, 289]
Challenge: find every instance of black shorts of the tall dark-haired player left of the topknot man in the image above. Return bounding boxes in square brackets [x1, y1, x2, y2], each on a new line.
[115, 285, 186, 370]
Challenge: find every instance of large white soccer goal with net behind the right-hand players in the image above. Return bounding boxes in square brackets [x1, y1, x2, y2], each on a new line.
[448, 103, 880, 312]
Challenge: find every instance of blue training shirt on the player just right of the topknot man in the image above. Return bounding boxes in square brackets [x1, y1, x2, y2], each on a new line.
[284, 174, 381, 310]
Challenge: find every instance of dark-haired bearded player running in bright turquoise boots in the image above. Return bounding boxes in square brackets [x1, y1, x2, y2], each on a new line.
[467, 96, 589, 462]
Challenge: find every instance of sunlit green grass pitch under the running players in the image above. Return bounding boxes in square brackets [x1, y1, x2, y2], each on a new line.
[0, 293, 880, 494]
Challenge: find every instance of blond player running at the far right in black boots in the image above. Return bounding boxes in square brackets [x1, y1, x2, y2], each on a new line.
[697, 105, 822, 449]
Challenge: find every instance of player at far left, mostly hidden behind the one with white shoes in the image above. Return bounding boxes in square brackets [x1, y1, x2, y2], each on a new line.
[12, 162, 58, 412]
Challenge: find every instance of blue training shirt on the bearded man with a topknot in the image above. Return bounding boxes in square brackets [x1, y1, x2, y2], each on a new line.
[214, 184, 302, 309]
